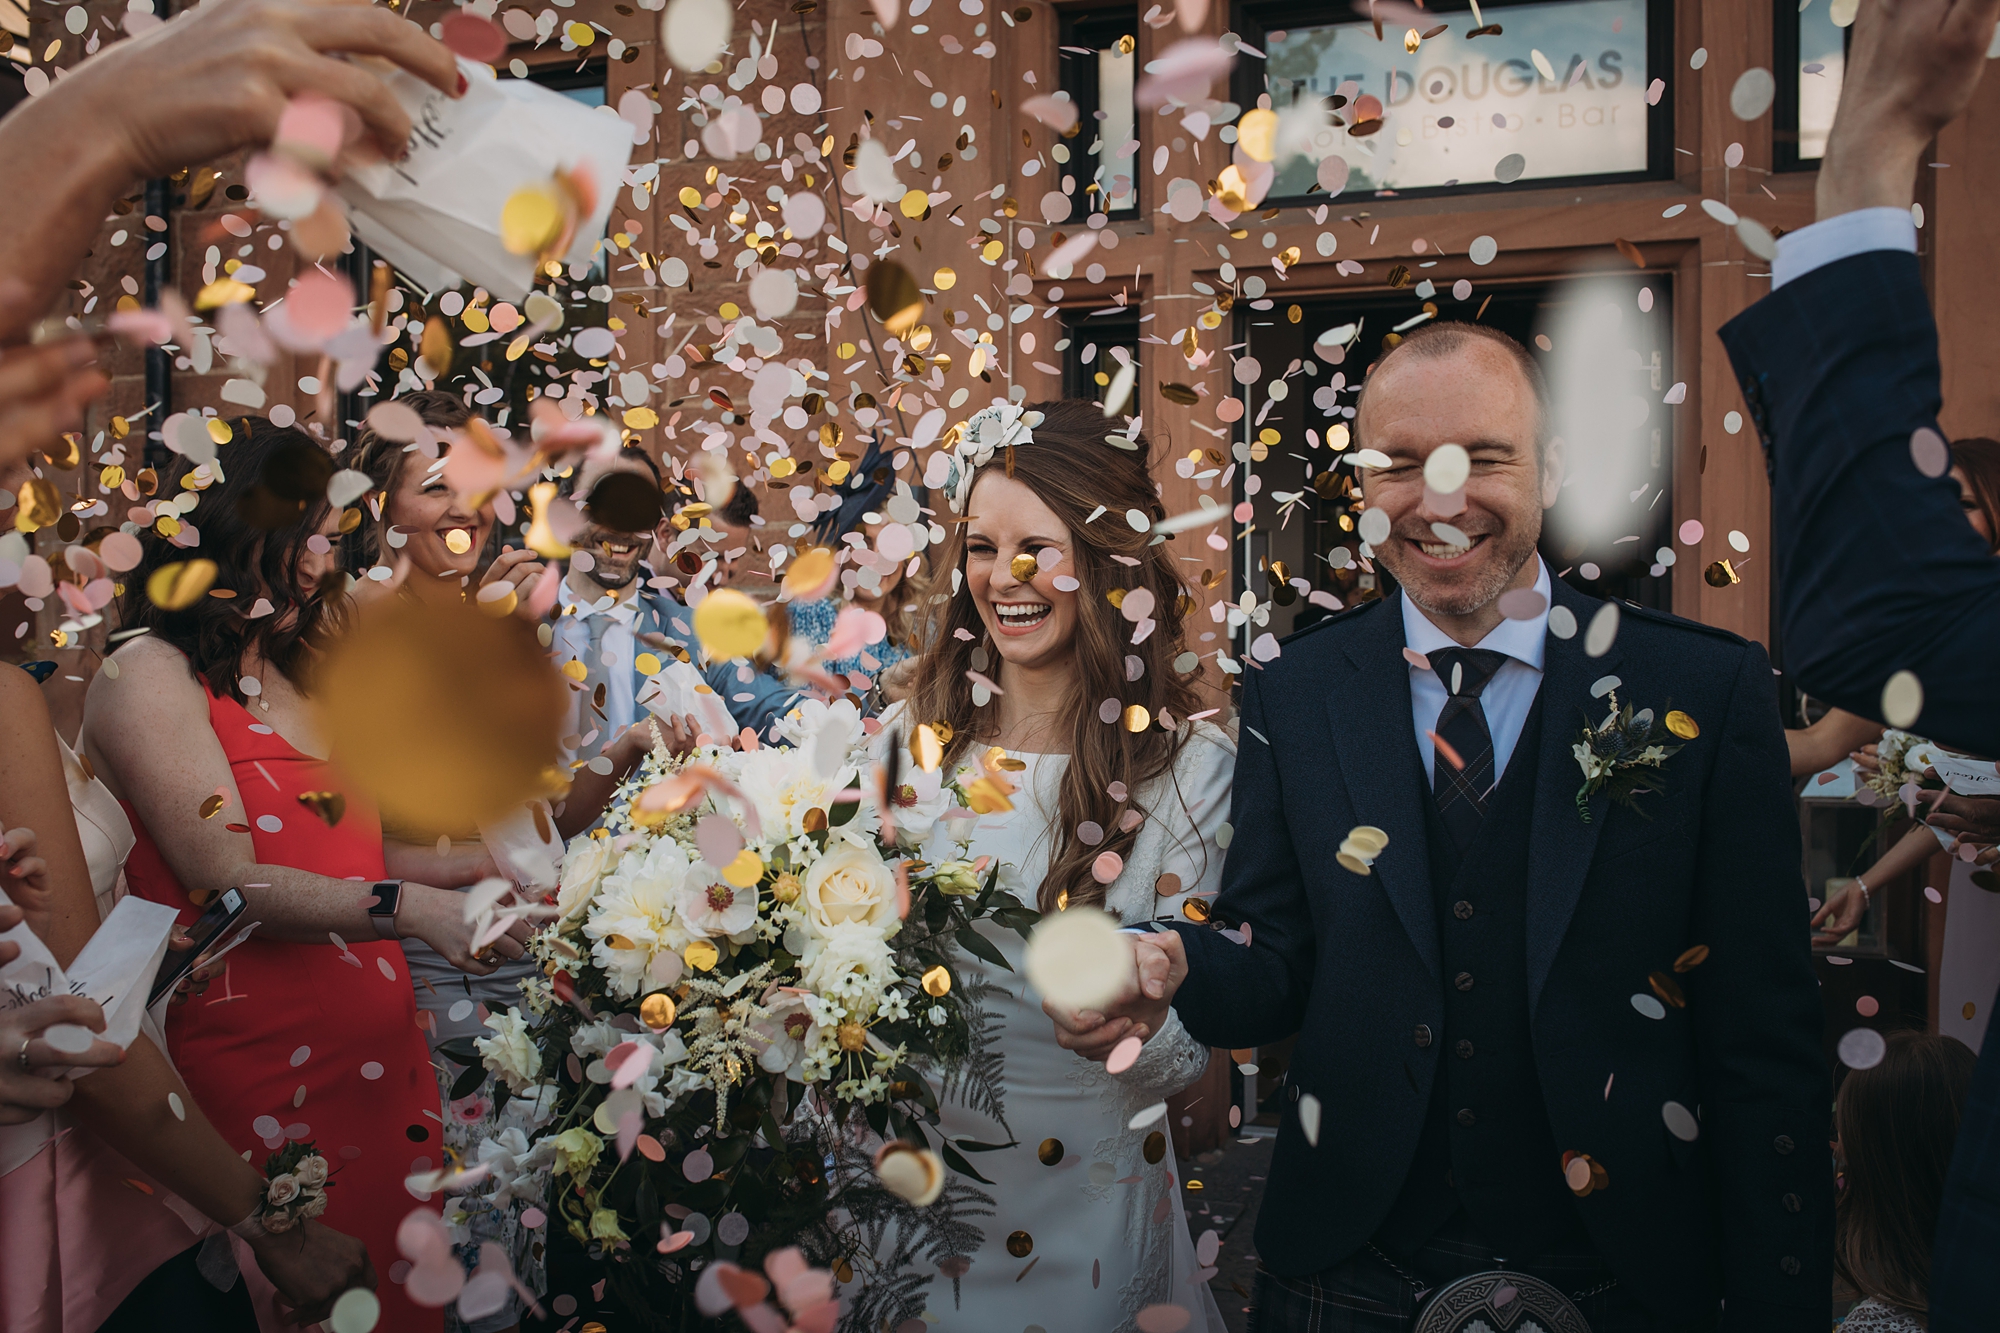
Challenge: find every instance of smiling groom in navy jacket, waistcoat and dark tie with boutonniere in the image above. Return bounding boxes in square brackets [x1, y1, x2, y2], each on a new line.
[1052, 322, 1832, 1333]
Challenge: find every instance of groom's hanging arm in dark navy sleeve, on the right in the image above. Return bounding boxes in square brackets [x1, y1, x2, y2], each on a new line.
[1684, 644, 1834, 1333]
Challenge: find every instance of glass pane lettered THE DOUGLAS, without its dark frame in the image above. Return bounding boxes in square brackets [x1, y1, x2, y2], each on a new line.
[1266, 0, 1664, 198]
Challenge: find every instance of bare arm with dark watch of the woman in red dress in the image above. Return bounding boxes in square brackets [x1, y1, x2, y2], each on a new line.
[82, 638, 522, 977]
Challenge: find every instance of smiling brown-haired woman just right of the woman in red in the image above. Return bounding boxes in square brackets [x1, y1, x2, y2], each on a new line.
[348, 390, 560, 1333]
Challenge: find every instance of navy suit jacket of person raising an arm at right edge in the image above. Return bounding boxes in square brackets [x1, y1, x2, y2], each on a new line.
[1722, 250, 2000, 1333]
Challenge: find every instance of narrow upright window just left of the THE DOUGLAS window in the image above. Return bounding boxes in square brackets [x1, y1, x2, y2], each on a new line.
[1054, 6, 1138, 218]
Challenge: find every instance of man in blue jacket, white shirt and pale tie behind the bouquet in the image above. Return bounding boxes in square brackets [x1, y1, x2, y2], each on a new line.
[550, 446, 798, 837]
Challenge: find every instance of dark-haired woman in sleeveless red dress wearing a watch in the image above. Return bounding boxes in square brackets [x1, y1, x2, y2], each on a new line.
[82, 418, 526, 1333]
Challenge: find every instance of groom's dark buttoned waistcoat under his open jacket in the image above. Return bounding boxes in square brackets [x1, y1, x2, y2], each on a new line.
[1376, 699, 1590, 1261]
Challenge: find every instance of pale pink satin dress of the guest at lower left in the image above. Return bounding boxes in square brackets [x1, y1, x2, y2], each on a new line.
[0, 741, 212, 1333]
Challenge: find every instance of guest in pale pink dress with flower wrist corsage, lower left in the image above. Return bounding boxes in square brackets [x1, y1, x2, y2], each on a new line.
[0, 669, 374, 1333]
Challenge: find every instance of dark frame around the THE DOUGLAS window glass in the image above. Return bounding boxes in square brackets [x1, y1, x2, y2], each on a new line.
[1230, 0, 1672, 208]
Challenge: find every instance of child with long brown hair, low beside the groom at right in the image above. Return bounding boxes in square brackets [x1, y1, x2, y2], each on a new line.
[1834, 1031, 1990, 1333]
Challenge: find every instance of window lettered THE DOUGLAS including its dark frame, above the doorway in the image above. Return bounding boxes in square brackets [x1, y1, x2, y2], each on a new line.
[1234, 0, 1672, 204]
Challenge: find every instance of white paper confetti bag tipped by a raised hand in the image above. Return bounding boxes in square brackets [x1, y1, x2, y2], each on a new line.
[340, 60, 632, 302]
